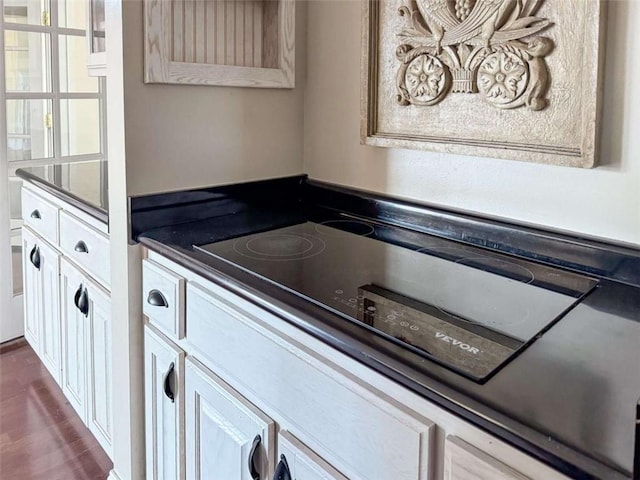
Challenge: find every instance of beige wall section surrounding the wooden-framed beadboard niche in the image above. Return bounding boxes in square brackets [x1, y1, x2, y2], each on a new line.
[123, 0, 306, 195]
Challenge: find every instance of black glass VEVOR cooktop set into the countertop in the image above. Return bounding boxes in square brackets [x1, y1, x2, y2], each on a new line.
[194, 216, 596, 382]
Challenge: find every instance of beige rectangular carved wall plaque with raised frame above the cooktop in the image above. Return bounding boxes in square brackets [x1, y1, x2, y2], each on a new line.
[362, 0, 605, 167]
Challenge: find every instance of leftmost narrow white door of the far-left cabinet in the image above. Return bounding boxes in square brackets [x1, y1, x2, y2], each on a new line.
[22, 228, 41, 353]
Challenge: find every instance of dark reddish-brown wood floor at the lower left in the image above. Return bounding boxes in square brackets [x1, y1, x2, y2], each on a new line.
[0, 340, 112, 480]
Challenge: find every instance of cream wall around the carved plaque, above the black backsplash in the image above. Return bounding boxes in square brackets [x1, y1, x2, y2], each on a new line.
[304, 0, 640, 244]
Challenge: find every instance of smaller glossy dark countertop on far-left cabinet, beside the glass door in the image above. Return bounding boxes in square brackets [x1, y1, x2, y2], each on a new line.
[16, 160, 109, 223]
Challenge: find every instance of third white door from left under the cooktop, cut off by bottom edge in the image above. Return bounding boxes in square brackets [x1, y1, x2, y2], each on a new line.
[275, 430, 348, 480]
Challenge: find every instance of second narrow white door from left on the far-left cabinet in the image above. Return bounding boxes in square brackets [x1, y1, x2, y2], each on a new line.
[39, 242, 61, 384]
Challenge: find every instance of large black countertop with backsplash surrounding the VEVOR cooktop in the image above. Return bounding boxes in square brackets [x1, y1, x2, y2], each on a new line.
[132, 178, 640, 480]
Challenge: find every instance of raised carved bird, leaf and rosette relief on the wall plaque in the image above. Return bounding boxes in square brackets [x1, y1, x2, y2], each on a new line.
[396, 0, 553, 110]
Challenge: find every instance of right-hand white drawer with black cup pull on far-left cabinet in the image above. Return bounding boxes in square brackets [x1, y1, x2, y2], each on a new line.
[60, 211, 111, 288]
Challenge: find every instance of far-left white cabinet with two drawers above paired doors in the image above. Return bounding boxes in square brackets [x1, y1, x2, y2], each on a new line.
[22, 185, 113, 456]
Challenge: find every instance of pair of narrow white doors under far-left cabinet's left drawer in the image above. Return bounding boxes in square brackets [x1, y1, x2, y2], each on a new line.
[22, 228, 60, 383]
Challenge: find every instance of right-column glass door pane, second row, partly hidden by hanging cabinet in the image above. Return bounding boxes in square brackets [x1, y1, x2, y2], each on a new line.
[59, 35, 98, 93]
